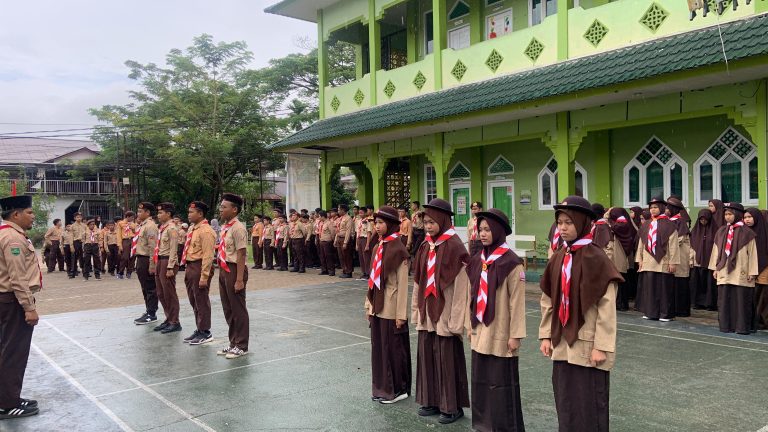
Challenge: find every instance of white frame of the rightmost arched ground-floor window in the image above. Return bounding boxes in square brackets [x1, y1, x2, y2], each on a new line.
[693, 127, 759, 207]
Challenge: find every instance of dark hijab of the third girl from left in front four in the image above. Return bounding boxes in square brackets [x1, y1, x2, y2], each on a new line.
[467, 217, 522, 328]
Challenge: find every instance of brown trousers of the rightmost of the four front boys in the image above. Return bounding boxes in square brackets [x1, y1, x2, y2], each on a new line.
[219, 262, 249, 351]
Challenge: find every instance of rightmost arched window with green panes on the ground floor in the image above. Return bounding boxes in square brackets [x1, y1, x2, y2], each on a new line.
[693, 127, 757, 207]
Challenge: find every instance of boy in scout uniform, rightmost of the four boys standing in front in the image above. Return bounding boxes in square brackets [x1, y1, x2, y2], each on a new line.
[217, 193, 249, 359]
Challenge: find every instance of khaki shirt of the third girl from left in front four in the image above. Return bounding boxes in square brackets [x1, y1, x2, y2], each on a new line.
[465, 265, 526, 357]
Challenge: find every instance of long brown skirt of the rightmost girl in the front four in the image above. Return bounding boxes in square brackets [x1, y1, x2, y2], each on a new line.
[552, 361, 610, 432]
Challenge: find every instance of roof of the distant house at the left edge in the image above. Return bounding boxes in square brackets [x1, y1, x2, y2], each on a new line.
[0, 137, 100, 165]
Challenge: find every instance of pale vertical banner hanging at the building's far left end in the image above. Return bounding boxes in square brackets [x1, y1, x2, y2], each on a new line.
[285, 153, 320, 210]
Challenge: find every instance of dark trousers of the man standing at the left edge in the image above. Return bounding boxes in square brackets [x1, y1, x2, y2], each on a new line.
[0, 293, 34, 409]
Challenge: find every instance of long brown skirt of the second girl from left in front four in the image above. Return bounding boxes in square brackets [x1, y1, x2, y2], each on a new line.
[416, 330, 469, 414]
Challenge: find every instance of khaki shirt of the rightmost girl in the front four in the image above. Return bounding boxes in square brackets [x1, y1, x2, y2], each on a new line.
[539, 282, 617, 371]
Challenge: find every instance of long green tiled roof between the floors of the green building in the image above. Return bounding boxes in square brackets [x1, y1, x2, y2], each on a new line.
[268, 14, 768, 150]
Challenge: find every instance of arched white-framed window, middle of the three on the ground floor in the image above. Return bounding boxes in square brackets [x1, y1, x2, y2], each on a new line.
[624, 137, 688, 207]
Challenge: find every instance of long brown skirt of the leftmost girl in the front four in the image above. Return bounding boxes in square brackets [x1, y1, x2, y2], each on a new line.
[370, 316, 412, 400]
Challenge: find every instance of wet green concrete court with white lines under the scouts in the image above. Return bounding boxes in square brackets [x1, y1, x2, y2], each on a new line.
[0, 270, 768, 432]
